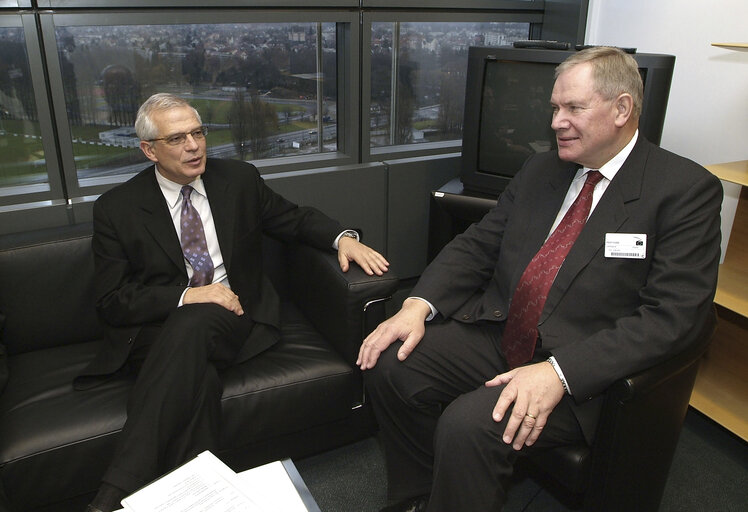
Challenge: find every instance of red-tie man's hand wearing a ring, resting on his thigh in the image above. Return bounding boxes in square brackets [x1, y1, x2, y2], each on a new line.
[486, 362, 564, 450]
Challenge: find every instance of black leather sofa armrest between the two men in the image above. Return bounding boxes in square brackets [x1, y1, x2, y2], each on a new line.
[286, 244, 398, 364]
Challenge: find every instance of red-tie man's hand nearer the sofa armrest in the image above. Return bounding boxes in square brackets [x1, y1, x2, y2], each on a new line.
[356, 298, 431, 370]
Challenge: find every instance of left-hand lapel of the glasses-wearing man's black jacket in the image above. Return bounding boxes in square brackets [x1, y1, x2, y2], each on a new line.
[136, 167, 187, 273]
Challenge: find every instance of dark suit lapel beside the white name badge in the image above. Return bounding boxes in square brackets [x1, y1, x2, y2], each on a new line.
[540, 138, 649, 322]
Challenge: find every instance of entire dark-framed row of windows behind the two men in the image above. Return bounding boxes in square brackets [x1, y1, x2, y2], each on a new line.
[0, 0, 568, 233]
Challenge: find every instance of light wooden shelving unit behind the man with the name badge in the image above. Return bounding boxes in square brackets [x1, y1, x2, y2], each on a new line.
[691, 160, 748, 440]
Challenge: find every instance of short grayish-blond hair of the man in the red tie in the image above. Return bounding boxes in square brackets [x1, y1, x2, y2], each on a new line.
[556, 46, 644, 118]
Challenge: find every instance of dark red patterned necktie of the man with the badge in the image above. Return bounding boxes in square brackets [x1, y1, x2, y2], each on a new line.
[501, 170, 603, 368]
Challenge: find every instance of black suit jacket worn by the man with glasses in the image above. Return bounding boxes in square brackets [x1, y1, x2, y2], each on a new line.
[82, 159, 343, 375]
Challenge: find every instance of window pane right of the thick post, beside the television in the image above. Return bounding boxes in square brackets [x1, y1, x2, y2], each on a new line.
[369, 21, 530, 154]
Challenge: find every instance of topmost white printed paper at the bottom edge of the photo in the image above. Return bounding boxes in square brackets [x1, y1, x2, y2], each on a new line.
[122, 451, 266, 512]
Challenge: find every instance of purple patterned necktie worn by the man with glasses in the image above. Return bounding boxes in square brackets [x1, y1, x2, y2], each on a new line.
[180, 185, 214, 286]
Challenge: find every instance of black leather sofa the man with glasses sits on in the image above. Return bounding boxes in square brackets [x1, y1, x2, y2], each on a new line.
[0, 225, 398, 512]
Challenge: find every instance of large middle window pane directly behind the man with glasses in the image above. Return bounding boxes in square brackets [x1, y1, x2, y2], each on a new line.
[42, 13, 356, 192]
